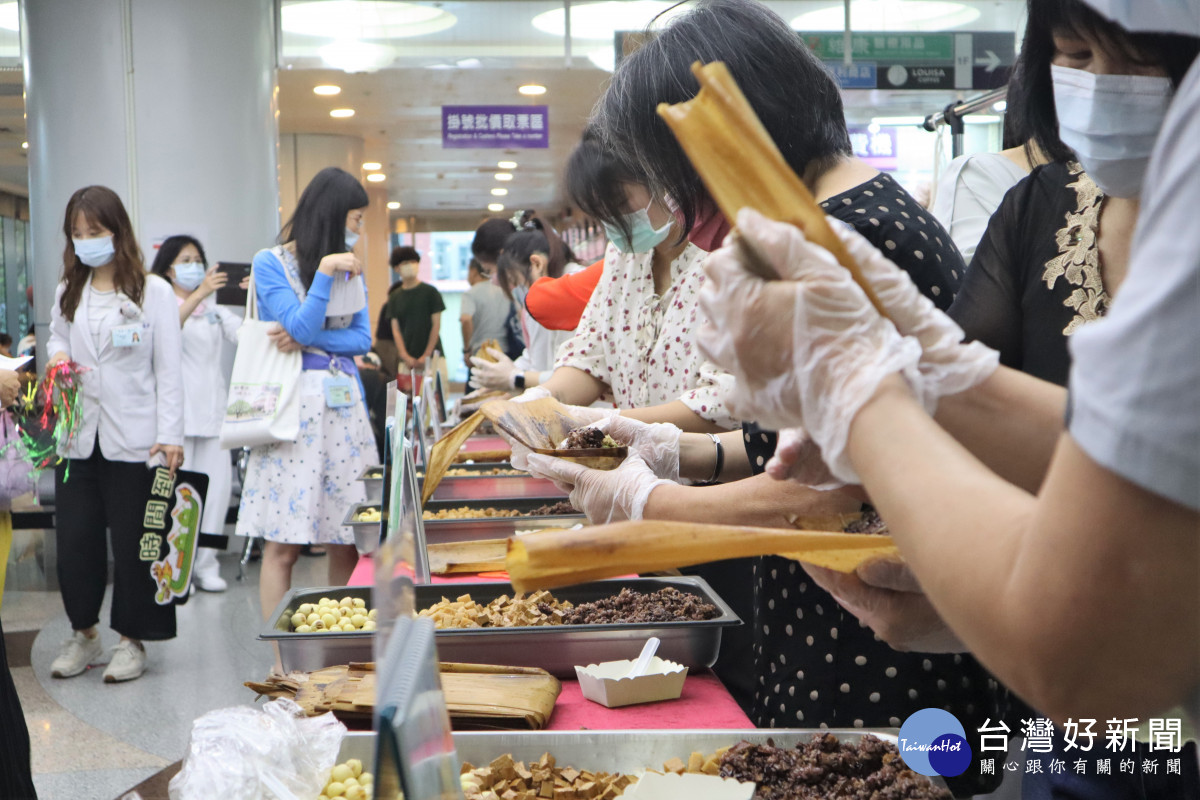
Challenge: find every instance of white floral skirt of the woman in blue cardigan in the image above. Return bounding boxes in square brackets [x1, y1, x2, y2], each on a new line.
[236, 369, 377, 545]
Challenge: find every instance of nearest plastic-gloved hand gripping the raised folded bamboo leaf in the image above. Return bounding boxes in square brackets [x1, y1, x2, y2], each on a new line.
[697, 209, 922, 483]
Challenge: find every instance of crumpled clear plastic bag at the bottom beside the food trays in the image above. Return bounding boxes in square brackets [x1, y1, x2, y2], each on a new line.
[169, 698, 346, 800]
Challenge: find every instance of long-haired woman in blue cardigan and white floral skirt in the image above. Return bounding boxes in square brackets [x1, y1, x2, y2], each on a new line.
[238, 167, 376, 633]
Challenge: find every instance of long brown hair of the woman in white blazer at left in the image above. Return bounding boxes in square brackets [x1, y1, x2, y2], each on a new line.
[59, 186, 146, 323]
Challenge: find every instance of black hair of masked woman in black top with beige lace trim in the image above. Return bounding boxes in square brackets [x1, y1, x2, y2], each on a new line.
[1008, 0, 1200, 162]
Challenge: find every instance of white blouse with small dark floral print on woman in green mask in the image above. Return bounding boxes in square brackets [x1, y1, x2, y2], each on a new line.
[554, 242, 740, 431]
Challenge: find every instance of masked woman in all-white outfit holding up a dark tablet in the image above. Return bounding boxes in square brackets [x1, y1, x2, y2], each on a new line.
[150, 236, 241, 591]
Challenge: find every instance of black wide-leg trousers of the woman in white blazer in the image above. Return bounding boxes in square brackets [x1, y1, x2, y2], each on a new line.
[54, 441, 175, 642]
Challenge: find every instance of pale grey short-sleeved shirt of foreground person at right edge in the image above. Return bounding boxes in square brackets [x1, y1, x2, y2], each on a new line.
[1069, 64, 1200, 510]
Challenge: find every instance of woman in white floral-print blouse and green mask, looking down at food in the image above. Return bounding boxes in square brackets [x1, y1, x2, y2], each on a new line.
[511, 130, 737, 434]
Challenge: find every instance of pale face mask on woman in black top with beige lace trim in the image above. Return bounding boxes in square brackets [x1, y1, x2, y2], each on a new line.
[1050, 66, 1172, 198]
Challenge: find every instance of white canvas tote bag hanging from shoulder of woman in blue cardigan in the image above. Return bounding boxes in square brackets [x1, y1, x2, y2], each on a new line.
[221, 271, 301, 449]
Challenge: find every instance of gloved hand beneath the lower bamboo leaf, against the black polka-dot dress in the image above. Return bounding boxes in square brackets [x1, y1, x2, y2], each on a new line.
[804, 559, 967, 652]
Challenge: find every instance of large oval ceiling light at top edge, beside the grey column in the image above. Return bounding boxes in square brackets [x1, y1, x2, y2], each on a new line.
[280, 0, 458, 40]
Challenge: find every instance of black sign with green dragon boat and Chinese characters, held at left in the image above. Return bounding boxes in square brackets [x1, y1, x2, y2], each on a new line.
[138, 467, 209, 606]
